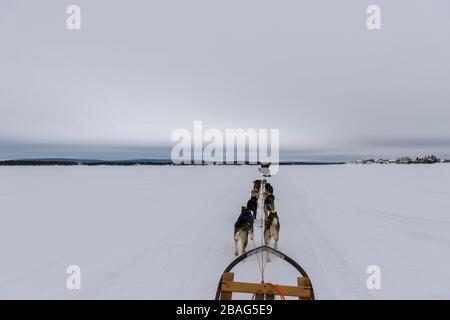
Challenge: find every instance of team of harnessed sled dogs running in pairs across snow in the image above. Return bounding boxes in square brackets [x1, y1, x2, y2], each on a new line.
[234, 179, 280, 256]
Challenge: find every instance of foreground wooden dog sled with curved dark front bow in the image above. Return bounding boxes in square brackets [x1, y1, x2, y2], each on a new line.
[215, 246, 314, 300]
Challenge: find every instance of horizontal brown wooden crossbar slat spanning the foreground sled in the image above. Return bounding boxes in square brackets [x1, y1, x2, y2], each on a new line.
[221, 278, 311, 299]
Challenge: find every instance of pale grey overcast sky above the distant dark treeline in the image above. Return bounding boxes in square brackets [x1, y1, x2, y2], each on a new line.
[0, 0, 450, 160]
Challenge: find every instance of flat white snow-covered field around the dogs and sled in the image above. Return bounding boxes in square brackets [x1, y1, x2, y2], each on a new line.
[0, 164, 450, 299]
